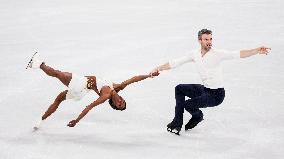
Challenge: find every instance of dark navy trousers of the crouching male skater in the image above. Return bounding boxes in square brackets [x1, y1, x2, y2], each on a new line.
[174, 84, 225, 125]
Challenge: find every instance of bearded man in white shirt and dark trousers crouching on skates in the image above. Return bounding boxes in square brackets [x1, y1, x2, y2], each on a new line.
[152, 29, 271, 135]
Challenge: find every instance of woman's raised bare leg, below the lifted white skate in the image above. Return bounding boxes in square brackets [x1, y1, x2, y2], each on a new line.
[40, 63, 72, 86]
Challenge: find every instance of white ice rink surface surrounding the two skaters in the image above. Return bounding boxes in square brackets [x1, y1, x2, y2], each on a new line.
[0, 0, 284, 159]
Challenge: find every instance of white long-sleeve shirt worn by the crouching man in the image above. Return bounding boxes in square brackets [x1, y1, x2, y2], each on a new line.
[169, 48, 240, 89]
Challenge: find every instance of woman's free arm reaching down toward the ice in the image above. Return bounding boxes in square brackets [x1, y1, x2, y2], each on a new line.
[67, 90, 111, 127]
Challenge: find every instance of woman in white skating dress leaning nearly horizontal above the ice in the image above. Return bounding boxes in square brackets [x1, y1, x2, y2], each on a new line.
[27, 53, 159, 130]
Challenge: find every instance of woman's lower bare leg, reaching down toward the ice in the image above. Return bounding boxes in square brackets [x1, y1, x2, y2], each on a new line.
[41, 90, 68, 120]
